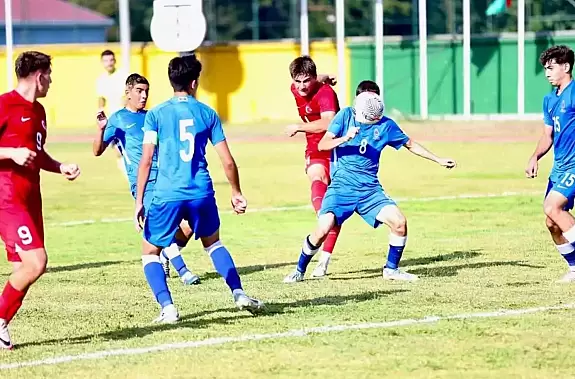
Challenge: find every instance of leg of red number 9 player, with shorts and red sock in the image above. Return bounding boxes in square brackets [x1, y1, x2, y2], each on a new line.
[0, 207, 48, 349]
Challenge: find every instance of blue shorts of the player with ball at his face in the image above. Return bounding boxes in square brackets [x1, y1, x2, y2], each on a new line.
[319, 186, 396, 228]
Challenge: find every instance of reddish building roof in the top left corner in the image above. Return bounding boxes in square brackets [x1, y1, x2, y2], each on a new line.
[0, 0, 114, 25]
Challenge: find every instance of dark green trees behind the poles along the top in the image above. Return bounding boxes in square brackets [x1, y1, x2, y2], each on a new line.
[70, 0, 575, 42]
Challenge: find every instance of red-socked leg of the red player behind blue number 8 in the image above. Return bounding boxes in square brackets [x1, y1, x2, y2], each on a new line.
[306, 158, 341, 277]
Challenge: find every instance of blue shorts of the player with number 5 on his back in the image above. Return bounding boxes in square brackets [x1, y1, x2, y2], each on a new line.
[144, 196, 220, 247]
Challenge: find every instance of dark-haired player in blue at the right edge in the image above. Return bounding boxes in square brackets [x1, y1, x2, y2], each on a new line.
[525, 46, 575, 283]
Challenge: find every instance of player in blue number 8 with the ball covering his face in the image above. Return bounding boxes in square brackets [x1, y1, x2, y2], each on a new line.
[284, 90, 456, 283]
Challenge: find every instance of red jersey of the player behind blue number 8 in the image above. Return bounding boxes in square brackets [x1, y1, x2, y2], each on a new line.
[291, 83, 339, 159]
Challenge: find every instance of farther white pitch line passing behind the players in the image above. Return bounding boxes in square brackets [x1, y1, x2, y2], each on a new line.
[48, 192, 541, 226]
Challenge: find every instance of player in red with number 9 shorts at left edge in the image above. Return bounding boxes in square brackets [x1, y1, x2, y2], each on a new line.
[0, 51, 80, 349]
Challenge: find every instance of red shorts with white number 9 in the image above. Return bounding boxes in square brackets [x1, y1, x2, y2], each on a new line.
[0, 202, 44, 262]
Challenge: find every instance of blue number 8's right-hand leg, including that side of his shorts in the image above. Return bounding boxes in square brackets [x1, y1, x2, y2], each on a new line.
[357, 189, 418, 281]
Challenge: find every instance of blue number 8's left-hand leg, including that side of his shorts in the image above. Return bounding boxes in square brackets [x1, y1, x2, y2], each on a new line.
[284, 187, 356, 283]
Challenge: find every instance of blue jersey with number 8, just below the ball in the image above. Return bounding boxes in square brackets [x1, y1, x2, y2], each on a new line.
[328, 107, 409, 190]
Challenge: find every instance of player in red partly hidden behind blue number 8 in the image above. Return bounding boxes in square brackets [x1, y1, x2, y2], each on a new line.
[286, 56, 341, 278]
